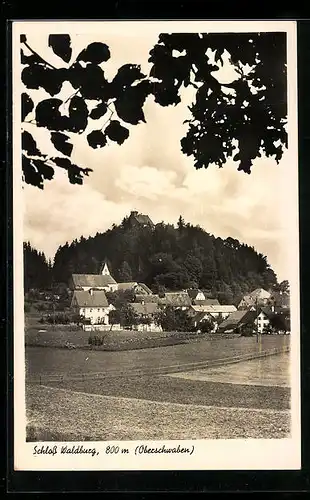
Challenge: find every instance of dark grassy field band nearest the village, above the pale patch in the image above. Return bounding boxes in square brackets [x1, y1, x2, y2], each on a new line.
[26, 335, 290, 377]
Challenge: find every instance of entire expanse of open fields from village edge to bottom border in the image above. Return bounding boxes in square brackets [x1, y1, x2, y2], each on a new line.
[26, 336, 290, 441]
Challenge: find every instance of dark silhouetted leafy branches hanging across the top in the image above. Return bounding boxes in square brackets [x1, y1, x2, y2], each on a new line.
[20, 32, 287, 189]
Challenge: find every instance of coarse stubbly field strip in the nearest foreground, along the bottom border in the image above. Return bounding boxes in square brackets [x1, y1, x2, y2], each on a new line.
[27, 385, 290, 441]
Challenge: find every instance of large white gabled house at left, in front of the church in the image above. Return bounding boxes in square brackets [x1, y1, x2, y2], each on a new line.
[71, 288, 115, 326]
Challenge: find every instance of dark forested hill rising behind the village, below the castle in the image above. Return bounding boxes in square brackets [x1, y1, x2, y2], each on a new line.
[24, 217, 277, 304]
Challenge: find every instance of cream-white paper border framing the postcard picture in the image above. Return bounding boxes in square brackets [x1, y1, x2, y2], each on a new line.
[12, 21, 301, 470]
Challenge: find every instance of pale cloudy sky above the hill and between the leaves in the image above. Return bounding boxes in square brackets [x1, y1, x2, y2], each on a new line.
[18, 24, 297, 281]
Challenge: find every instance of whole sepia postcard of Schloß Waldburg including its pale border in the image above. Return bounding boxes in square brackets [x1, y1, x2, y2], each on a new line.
[12, 21, 300, 470]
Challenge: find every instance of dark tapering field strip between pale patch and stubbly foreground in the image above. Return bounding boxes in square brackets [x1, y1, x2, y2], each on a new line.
[48, 368, 290, 410]
